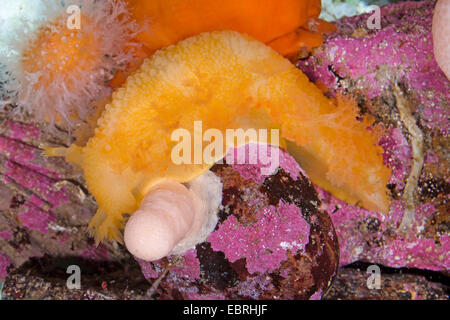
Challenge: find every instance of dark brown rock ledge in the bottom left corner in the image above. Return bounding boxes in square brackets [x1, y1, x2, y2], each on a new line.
[0, 255, 148, 300]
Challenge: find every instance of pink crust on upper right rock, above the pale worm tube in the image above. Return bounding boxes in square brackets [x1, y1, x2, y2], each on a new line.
[297, 1, 450, 135]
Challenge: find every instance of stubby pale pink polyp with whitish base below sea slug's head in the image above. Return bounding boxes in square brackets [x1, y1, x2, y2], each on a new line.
[124, 172, 222, 261]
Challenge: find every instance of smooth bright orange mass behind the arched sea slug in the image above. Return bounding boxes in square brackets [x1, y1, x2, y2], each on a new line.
[111, 0, 335, 87]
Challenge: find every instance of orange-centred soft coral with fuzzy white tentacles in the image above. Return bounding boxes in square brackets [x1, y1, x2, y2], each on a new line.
[0, 0, 137, 128]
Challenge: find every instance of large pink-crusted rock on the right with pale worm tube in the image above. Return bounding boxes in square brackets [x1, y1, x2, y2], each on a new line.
[297, 1, 450, 271]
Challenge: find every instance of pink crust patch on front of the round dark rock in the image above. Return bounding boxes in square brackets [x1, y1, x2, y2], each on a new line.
[209, 201, 309, 274]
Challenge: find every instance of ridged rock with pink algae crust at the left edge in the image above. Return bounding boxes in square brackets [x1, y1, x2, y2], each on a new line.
[0, 112, 128, 268]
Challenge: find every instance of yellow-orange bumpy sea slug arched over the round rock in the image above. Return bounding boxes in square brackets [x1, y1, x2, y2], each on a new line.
[48, 31, 389, 241]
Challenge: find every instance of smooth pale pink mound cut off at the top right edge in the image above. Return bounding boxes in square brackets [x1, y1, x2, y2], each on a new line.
[433, 0, 450, 79]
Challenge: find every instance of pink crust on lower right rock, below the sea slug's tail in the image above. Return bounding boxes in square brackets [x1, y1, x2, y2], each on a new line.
[317, 188, 450, 271]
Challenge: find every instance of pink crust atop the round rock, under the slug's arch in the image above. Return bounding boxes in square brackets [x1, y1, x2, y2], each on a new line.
[225, 143, 307, 183]
